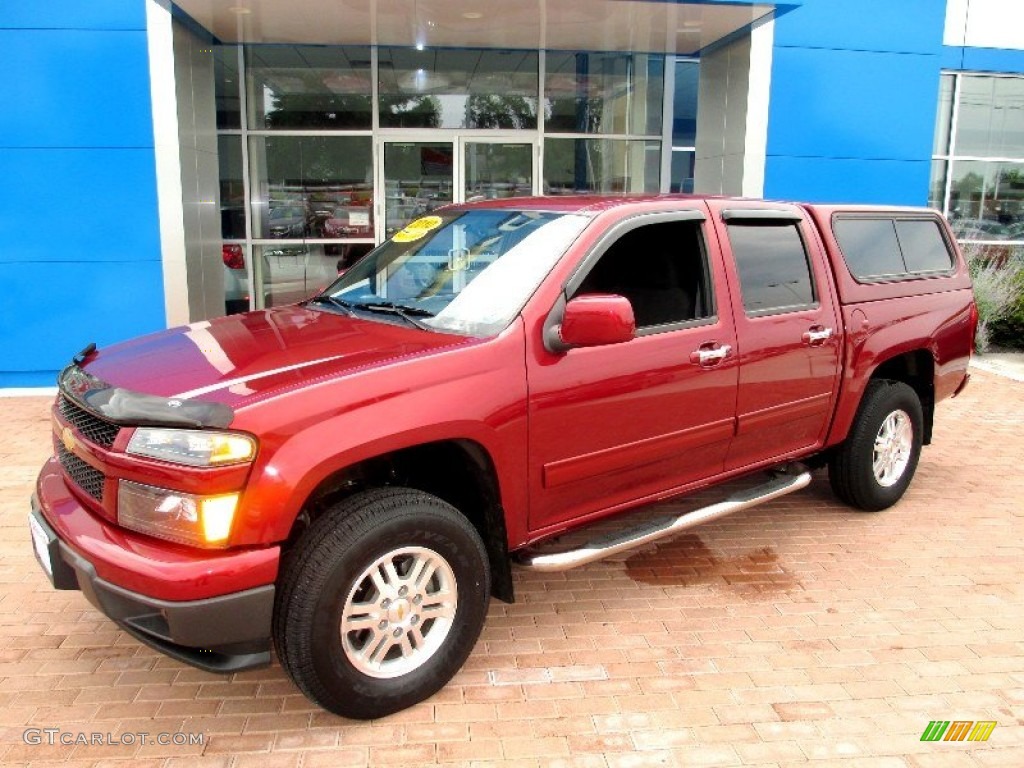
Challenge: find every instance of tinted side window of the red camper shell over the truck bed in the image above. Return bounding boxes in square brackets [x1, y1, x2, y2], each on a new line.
[833, 216, 952, 280]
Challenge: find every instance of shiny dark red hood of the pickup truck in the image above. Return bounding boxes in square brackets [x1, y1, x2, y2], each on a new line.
[82, 306, 477, 408]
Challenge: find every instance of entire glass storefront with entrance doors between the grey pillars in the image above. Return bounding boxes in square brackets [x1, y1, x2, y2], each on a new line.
[214, 44, 671, 319]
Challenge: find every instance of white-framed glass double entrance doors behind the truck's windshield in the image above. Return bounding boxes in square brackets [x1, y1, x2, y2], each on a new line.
[378, 134, 537, 240]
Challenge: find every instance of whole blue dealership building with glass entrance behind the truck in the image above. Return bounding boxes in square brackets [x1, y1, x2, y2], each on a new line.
[0, 0, 1024, 391]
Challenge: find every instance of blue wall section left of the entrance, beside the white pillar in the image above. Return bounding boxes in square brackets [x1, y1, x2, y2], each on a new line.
[0, 0, 164, 387]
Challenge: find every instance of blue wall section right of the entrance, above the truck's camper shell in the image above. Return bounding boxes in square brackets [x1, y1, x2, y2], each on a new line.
[764, 0, 948, 205]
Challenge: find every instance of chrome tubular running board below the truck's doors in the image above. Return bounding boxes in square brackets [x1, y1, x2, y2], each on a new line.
[514, 465, 811, 571]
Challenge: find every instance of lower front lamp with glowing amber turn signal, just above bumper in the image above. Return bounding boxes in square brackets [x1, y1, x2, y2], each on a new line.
[118, 480, 239, 547]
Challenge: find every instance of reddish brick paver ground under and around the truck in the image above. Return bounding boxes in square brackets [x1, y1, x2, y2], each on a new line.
[0, 374, 1024, 768]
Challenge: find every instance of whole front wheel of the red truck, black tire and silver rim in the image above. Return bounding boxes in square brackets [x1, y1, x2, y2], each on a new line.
[273, 487, 490, 720]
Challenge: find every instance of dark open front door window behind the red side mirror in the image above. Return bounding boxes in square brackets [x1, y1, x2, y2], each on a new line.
[573, 221, 715, 329]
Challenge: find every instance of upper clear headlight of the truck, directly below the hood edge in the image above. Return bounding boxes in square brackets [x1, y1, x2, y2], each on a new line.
[126, 427, 256, 467]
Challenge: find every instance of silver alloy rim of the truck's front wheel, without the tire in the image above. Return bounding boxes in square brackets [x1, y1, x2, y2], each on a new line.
[340, 547, 459, 678]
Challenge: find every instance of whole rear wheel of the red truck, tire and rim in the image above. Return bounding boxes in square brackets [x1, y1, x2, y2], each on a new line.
[828, 379, 924, 512]
